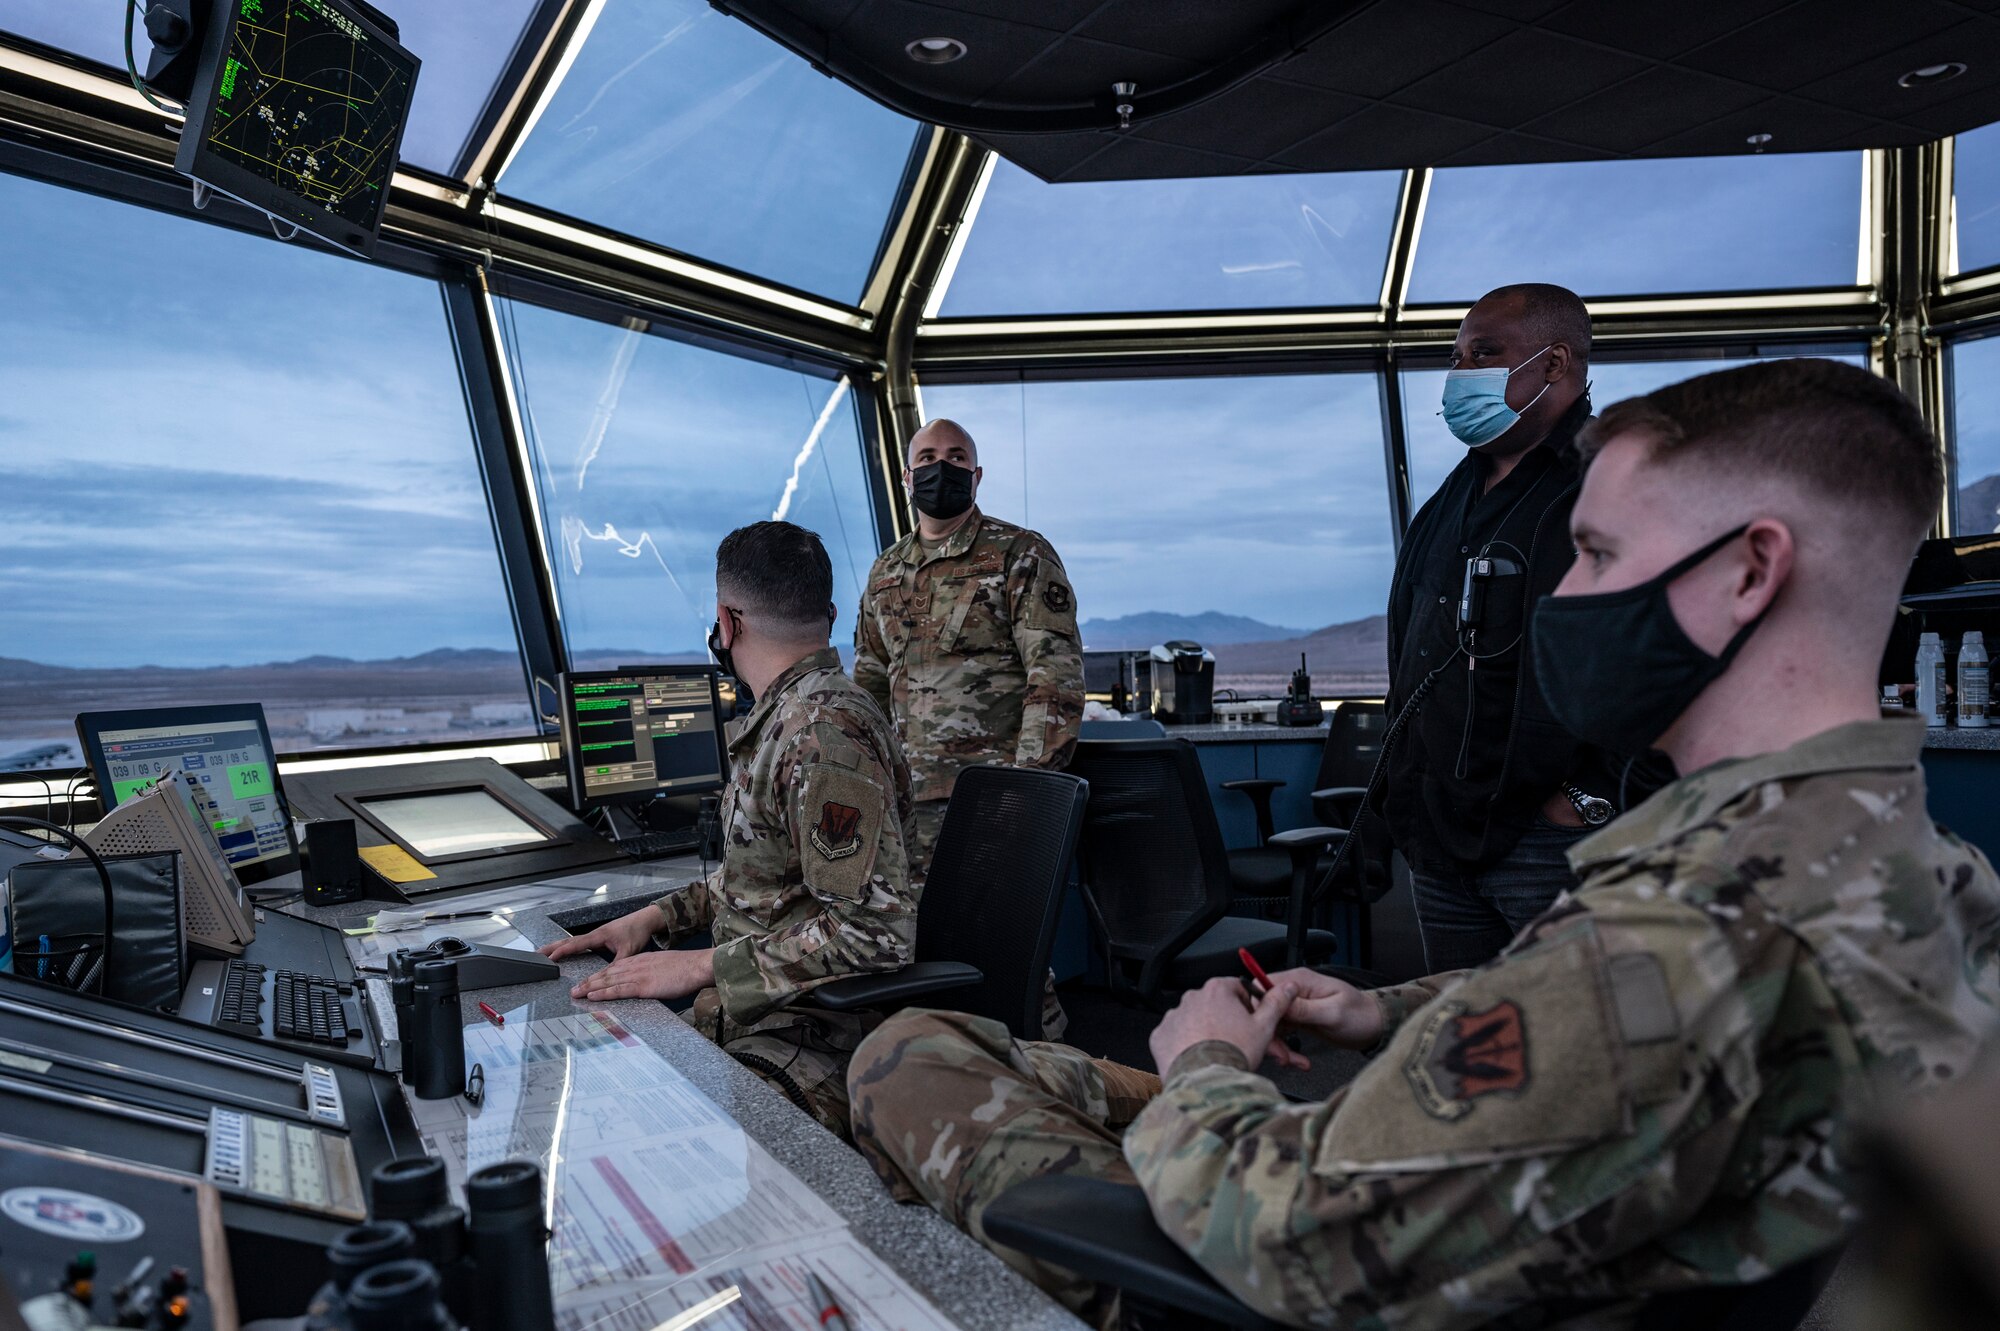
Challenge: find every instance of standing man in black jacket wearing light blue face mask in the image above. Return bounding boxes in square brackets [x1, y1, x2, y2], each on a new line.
[1382, 284, 1654, 971]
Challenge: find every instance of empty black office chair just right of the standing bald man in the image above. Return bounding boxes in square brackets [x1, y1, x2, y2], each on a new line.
[1070, 739, 1342, 1007]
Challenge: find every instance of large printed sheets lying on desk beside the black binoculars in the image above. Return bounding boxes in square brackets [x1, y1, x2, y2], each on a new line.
[402, 1011, 952, 1331]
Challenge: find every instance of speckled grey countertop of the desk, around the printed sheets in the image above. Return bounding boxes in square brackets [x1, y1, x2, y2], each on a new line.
[288, 857, 1084, 1331]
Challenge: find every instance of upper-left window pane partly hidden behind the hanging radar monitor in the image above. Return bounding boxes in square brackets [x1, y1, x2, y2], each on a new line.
[0, 0, 538, 172]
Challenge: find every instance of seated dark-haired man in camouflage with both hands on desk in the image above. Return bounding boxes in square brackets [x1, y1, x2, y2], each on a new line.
[542, 522, 920, 1135]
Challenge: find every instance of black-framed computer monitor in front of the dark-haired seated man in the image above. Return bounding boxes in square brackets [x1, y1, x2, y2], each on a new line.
[556, 666, 728, 813]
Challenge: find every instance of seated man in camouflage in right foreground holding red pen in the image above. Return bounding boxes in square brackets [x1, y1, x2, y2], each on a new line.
[850, 362, 2000, 1329]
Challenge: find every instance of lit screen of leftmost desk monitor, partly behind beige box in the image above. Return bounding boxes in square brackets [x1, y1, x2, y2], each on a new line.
[98, 721, 292, 865]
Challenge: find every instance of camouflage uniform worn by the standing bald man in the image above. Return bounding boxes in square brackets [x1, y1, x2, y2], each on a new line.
[854, 508, 1084, 1035]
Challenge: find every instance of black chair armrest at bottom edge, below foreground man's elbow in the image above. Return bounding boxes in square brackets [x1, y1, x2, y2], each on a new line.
[982, 1173, 1280, 1331]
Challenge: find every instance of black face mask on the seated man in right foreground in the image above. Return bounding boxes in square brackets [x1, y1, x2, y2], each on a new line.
[1534, 524, 1770, 757]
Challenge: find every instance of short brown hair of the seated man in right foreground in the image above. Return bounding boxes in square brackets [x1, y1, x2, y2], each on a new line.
[1580, 358, 1944, 550]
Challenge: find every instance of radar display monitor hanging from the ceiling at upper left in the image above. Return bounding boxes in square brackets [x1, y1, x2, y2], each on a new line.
[174, 0, 420, 254]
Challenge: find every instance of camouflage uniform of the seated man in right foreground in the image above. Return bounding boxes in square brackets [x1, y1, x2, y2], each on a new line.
[848, 721, 2000, 1327]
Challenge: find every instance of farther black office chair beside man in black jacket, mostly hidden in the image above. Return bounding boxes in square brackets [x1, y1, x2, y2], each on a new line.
[1222, 701, 1394, 967]
